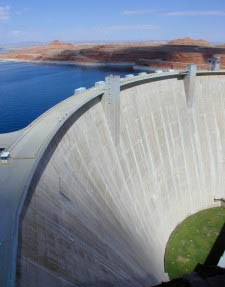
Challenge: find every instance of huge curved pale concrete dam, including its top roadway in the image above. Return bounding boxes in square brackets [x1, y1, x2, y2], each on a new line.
[0, 67, 225, 287]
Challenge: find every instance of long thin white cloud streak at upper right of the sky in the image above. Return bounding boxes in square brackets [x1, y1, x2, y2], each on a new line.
[123, 9, 225, 17]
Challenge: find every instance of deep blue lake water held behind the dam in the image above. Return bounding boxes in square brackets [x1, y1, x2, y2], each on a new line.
[0, 62, 133, 133]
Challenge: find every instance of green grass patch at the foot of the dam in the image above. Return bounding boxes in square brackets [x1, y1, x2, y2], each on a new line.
[165, 207, 225, 279]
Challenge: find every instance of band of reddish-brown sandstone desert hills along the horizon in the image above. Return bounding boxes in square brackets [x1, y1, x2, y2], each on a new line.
[0, 38, 225, 69]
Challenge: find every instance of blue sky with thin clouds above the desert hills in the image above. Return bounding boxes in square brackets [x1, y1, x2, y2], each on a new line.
[0, 0, 225, 44]
